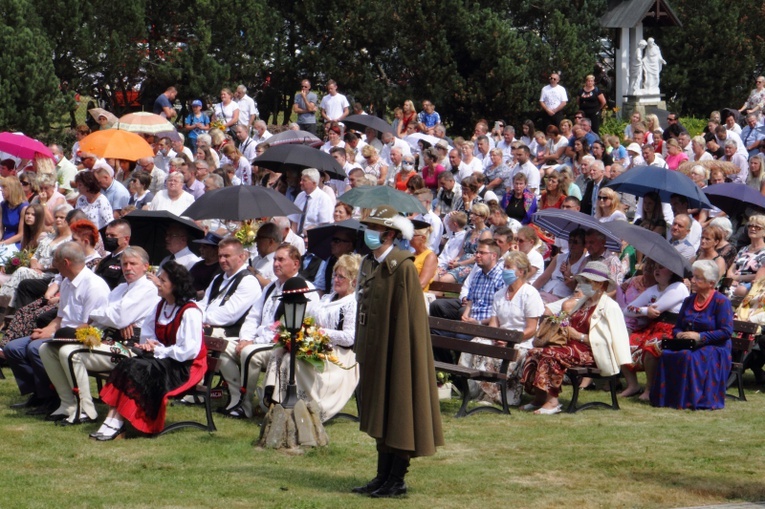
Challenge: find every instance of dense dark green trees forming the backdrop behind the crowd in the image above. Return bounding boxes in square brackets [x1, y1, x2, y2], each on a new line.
[0, 0, 765, 135]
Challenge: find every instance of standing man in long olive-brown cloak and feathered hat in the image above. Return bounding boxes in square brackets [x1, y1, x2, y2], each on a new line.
[353, 206, 444, 498]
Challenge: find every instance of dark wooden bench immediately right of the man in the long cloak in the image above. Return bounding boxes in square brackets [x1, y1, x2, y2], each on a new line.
[430, 316, 523, 417]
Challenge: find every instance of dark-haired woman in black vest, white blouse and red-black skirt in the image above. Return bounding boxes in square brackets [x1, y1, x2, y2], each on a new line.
[90, 261, 207, 441]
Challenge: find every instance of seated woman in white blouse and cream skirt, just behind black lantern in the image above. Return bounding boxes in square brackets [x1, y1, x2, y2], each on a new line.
[264, 255, 361, 421]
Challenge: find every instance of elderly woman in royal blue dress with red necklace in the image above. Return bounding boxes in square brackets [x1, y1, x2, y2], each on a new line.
[645, 260, 733, 410]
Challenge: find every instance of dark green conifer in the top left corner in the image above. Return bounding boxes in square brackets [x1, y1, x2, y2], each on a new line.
[0, 0, 67, 136]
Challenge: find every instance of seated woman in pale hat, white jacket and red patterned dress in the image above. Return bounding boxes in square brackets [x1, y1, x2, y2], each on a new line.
[521, 262, 632, 415]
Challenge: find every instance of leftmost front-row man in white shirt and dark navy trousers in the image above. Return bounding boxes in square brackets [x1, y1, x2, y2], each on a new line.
[3, 242, 109, 415]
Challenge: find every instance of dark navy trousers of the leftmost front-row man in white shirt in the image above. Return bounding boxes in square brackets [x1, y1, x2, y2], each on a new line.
[3, 336, 56, 399]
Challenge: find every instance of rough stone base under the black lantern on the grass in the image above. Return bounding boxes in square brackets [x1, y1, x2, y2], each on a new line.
[258, 400, 329, 450]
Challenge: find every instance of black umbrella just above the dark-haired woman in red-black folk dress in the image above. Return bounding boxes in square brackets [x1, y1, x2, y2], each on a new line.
[124, 210, 205, 265]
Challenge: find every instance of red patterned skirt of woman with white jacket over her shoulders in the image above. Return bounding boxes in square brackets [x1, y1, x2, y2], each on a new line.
[521, 339, 595, 398]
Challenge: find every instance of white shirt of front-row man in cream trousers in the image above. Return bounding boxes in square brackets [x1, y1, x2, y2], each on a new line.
[90, 276, 159, 329]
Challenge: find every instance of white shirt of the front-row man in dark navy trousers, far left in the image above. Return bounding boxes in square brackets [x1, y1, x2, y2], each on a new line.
[57, 267, 110, 327]
